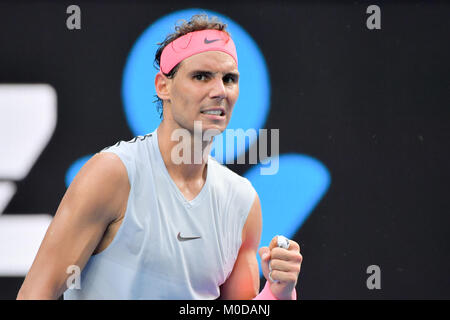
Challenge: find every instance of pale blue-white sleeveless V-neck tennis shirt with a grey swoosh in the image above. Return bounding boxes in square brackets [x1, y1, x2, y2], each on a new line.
[64, 130, 256, 300]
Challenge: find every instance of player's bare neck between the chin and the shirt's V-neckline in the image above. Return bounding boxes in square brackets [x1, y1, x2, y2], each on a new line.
[158, 119, 213, 181]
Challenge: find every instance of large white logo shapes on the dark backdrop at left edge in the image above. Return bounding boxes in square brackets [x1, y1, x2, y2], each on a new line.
[0, 84, 57, 276]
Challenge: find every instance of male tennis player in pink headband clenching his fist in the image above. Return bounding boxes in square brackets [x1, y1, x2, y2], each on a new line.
[18, 15, 302, 299]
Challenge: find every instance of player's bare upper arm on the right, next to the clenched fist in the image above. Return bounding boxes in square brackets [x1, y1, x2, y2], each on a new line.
[220, 195, 262, 300]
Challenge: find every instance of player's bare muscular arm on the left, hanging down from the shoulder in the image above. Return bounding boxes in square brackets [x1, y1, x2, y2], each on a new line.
[17, 153, 130, 299]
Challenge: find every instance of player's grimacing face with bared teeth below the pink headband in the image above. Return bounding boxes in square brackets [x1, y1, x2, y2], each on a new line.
[164, 51, 239, 132]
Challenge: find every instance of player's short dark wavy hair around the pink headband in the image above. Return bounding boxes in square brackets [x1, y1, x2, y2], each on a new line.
[153, 13, 230, 118]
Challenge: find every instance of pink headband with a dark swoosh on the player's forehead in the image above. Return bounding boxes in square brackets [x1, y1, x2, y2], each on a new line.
[160, 29, 237, 74]
